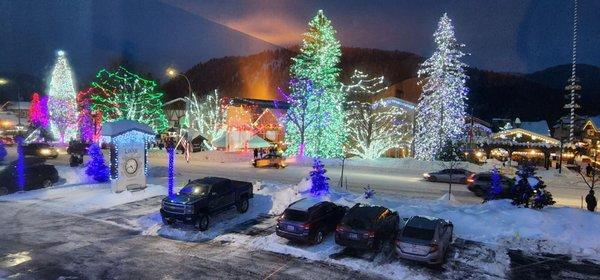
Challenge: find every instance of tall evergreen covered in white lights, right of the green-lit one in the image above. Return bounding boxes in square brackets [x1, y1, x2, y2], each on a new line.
[414, 14, 469, 160]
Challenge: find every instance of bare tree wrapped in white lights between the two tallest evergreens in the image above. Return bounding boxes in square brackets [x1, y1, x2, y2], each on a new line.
[343, 70, 411, 159]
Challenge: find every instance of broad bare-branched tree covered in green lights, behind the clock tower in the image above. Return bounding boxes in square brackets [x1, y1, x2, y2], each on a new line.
[92, 67, 168, 132]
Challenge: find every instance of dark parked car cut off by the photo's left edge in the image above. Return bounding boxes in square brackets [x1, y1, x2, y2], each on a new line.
[0, 158, 59, 195]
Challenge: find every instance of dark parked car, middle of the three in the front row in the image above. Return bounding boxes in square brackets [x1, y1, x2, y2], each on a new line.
[335, 203, 400, 250]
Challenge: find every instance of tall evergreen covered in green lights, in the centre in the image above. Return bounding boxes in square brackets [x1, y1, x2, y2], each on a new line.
[287, 10, 346, 157]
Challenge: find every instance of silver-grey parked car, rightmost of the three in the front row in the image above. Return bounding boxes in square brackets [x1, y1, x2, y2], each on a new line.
[396, 216, 454, 264]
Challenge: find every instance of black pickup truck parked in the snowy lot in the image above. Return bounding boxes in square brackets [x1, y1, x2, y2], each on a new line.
[160, 177, 254, 231]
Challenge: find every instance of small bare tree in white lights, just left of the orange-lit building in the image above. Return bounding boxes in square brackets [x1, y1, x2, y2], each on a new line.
[184, 90, 226, 150]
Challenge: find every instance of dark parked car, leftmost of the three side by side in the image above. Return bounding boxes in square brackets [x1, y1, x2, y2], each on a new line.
[275, 198, 347, 244]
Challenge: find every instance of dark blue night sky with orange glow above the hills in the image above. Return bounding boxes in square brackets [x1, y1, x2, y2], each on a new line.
[0, 0, 600, 83]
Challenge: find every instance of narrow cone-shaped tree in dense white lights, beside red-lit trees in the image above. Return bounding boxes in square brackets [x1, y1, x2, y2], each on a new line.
[48, 51, 77, 143]
